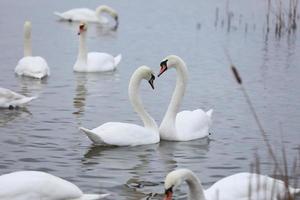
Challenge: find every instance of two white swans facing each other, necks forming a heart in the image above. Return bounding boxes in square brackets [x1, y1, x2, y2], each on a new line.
[80, 55, 212, 146]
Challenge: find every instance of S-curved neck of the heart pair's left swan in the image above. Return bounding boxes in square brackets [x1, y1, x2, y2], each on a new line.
[128, 73, 158, 131]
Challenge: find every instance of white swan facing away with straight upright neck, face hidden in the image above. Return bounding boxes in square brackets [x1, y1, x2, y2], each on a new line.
[15, 21, 50, 79]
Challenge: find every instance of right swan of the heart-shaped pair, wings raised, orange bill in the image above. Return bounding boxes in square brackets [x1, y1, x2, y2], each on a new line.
[158, 55, 213, 141]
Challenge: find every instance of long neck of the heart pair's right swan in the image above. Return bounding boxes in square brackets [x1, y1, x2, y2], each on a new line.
[163, 60, 188, 125]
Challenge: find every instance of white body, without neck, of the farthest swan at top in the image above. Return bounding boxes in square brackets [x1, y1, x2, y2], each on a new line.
[54, 8, 99, 22]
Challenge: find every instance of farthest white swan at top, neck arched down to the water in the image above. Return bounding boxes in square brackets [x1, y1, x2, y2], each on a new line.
[54, 5, 119, 28]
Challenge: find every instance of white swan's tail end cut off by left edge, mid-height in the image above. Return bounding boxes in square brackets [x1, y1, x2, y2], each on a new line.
[0, 87, 37, 109]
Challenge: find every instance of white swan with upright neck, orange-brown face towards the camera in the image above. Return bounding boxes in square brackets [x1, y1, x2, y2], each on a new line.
[73, 23, 122, 72]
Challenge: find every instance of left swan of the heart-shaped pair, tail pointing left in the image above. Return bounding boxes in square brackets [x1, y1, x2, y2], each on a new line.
[80, 66, 159, 146]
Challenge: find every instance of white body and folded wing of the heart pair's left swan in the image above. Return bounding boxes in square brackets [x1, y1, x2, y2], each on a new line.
[81, 122, 159, 146]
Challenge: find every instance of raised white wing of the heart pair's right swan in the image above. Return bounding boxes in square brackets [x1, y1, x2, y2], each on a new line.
[176, 109, 212, 141]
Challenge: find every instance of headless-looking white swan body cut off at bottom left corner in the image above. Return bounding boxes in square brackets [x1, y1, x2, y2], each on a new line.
[0, 171, 109, 200]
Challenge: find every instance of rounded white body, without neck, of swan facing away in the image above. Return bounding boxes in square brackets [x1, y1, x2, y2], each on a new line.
[15, 56, 50, 79]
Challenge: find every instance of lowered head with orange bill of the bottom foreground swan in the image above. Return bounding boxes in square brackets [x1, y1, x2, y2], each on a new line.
[164, 169, 193, 200]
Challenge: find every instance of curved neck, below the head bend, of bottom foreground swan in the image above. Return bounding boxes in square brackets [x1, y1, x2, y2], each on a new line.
[185, 173, 205, 200]
